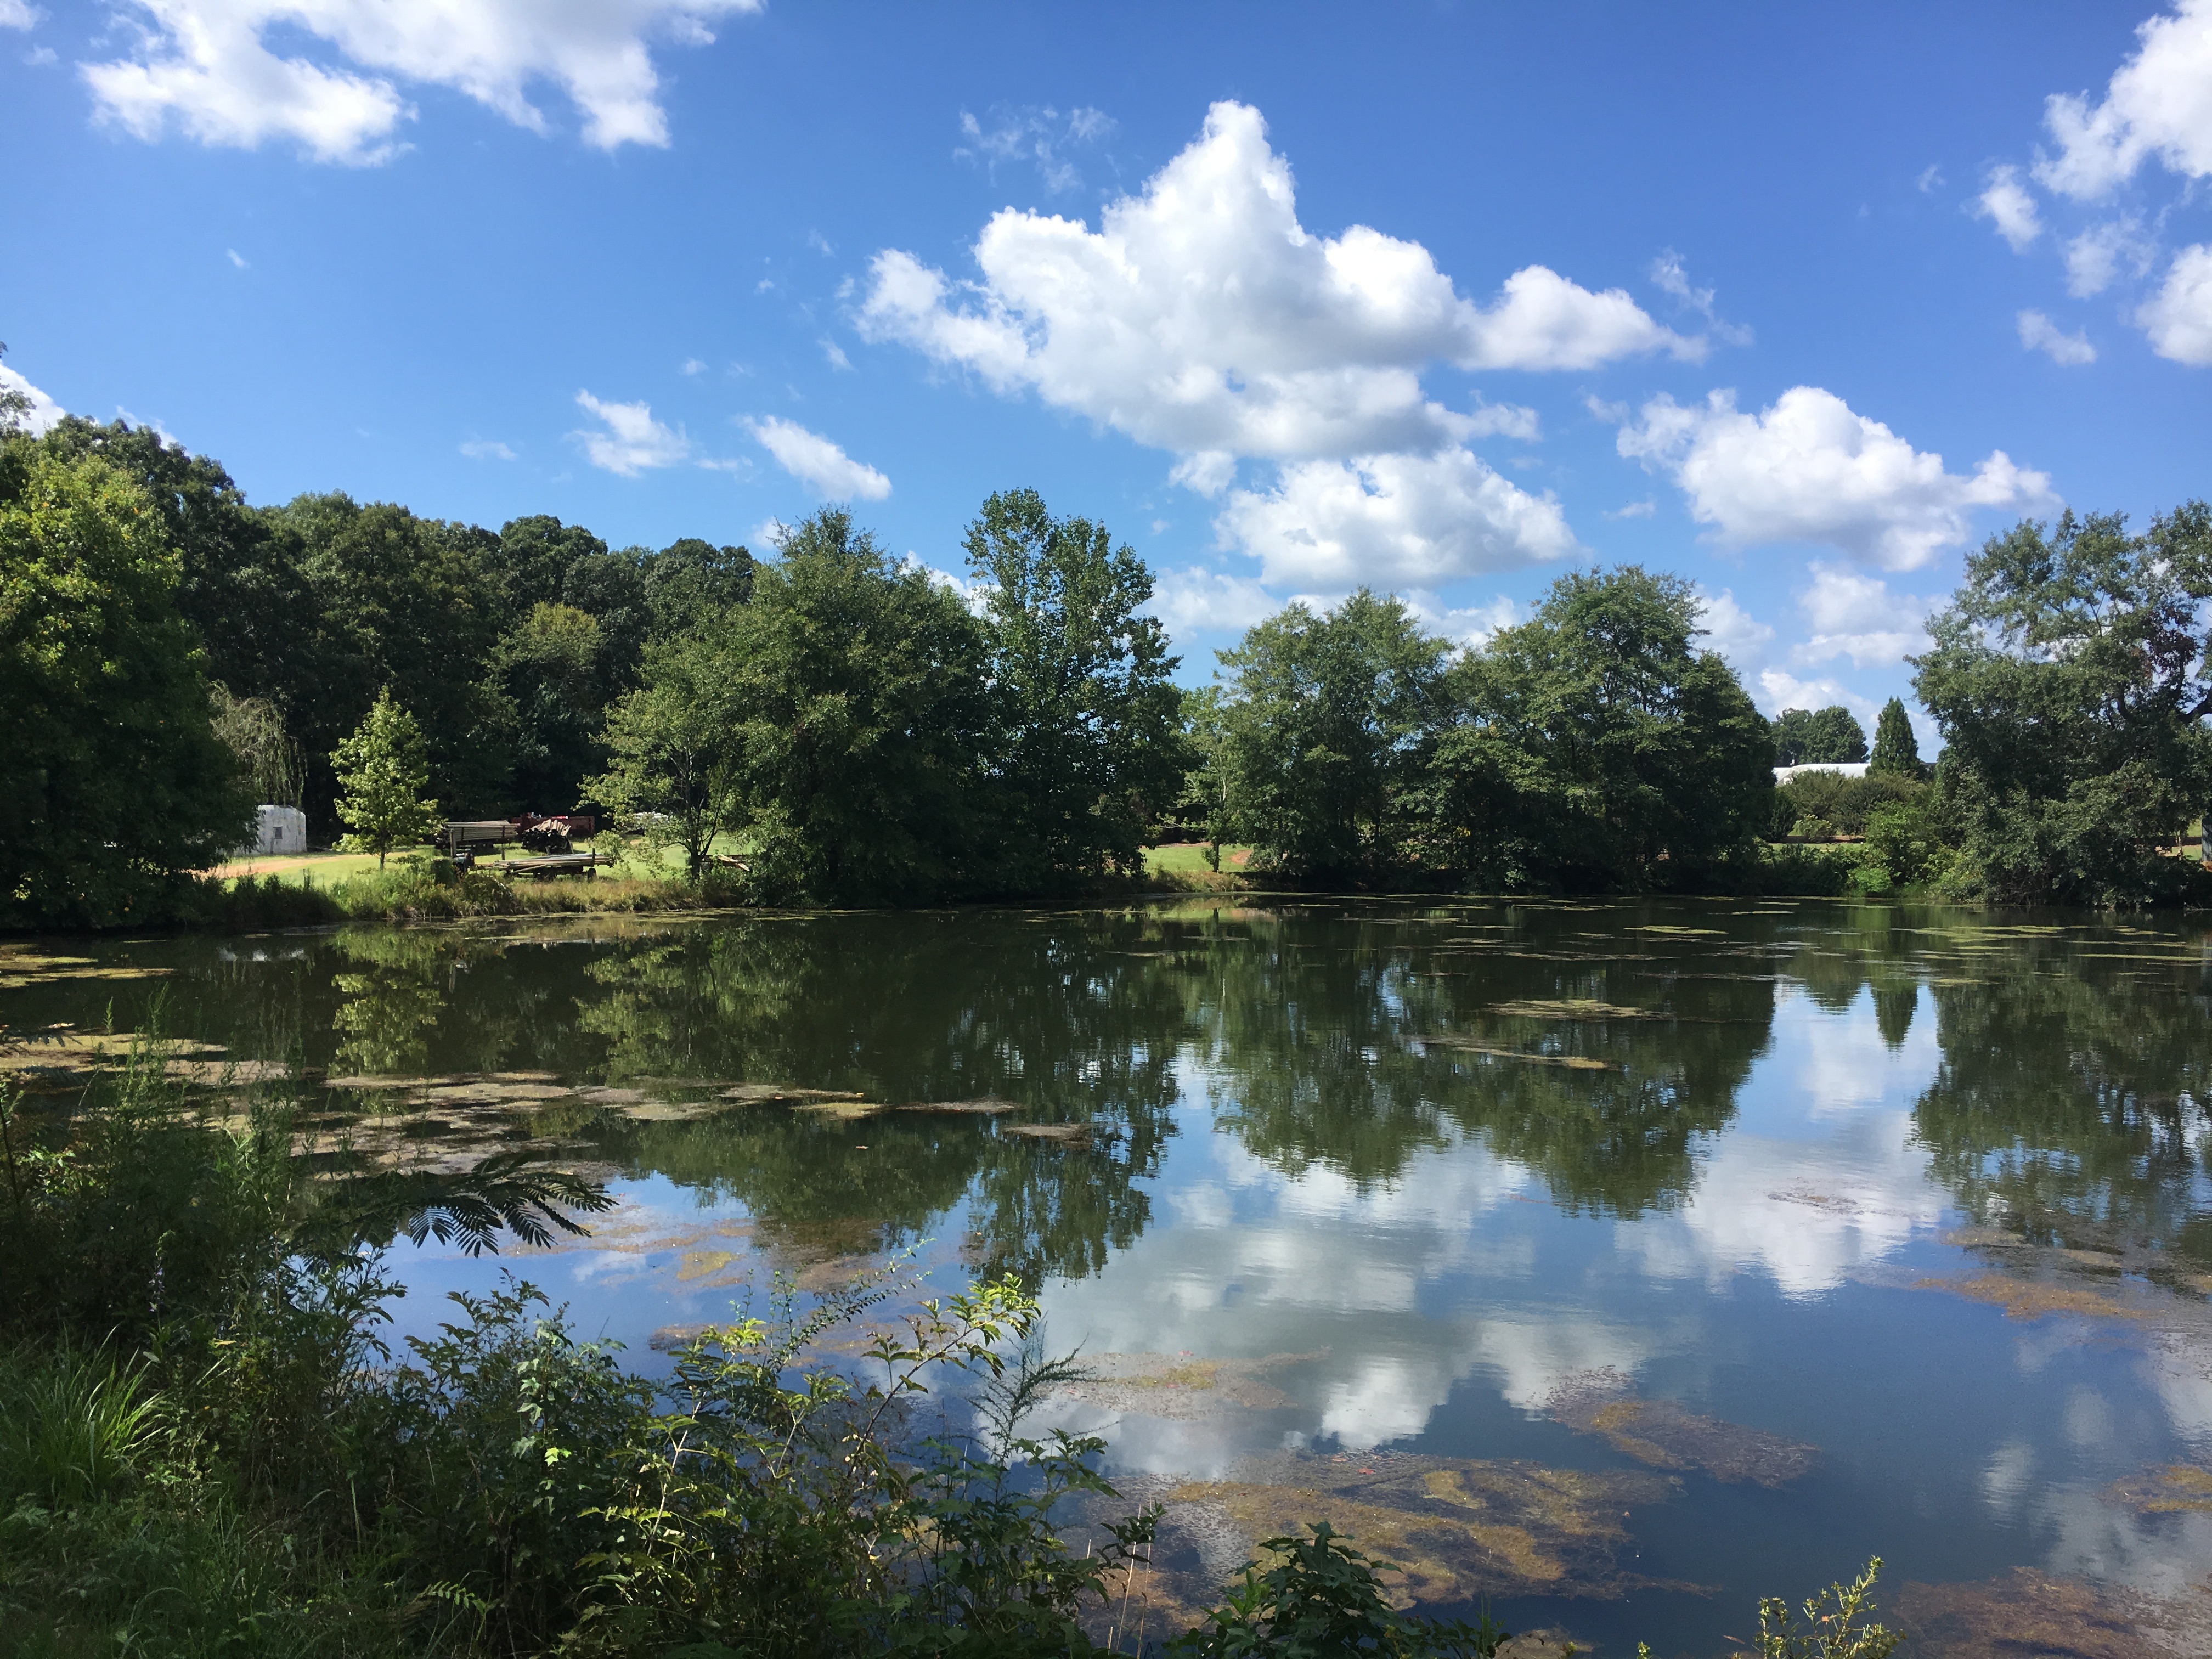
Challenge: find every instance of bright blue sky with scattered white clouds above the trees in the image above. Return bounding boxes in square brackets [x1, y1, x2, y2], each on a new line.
[0, 0, 2212, 716]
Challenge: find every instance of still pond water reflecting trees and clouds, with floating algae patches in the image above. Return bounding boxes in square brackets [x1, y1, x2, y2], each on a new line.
[0, 896, 2212, 1655]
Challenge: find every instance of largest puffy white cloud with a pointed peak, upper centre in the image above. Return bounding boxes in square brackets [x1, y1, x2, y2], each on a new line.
[858, 101, 1703, 460]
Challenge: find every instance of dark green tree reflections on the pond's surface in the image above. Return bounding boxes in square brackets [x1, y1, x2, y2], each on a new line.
[316, 900, 2212, 1283]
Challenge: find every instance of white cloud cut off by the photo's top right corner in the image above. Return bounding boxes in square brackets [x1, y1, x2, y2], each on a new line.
[2035, 0, 2212, 201]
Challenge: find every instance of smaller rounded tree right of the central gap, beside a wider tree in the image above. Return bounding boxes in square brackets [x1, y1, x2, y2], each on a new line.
[1221, 589, 1447, 883]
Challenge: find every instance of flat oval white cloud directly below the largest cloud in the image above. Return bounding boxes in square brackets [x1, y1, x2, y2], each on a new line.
[1217, 449, 1575, 591]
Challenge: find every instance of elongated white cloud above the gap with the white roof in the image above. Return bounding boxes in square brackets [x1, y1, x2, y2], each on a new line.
[1617, 385, 2051, 571]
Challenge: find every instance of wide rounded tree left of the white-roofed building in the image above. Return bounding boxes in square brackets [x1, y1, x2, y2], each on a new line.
[1429, 564, 1774, 889]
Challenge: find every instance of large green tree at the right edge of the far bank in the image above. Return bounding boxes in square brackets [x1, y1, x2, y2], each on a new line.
[1914, 502, 2212, 905]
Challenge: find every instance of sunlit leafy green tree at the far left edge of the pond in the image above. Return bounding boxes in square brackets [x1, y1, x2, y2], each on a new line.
[0, 449, 250, 927]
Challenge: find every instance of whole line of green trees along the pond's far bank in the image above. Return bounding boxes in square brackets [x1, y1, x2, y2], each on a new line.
[0, 378, 2212, 924]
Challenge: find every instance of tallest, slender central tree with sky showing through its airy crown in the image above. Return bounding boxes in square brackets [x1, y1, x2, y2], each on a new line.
[967, 489, 1183, 885]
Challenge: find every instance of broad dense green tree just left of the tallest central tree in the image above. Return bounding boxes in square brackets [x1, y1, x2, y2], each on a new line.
[714, 506, 991, 902]
